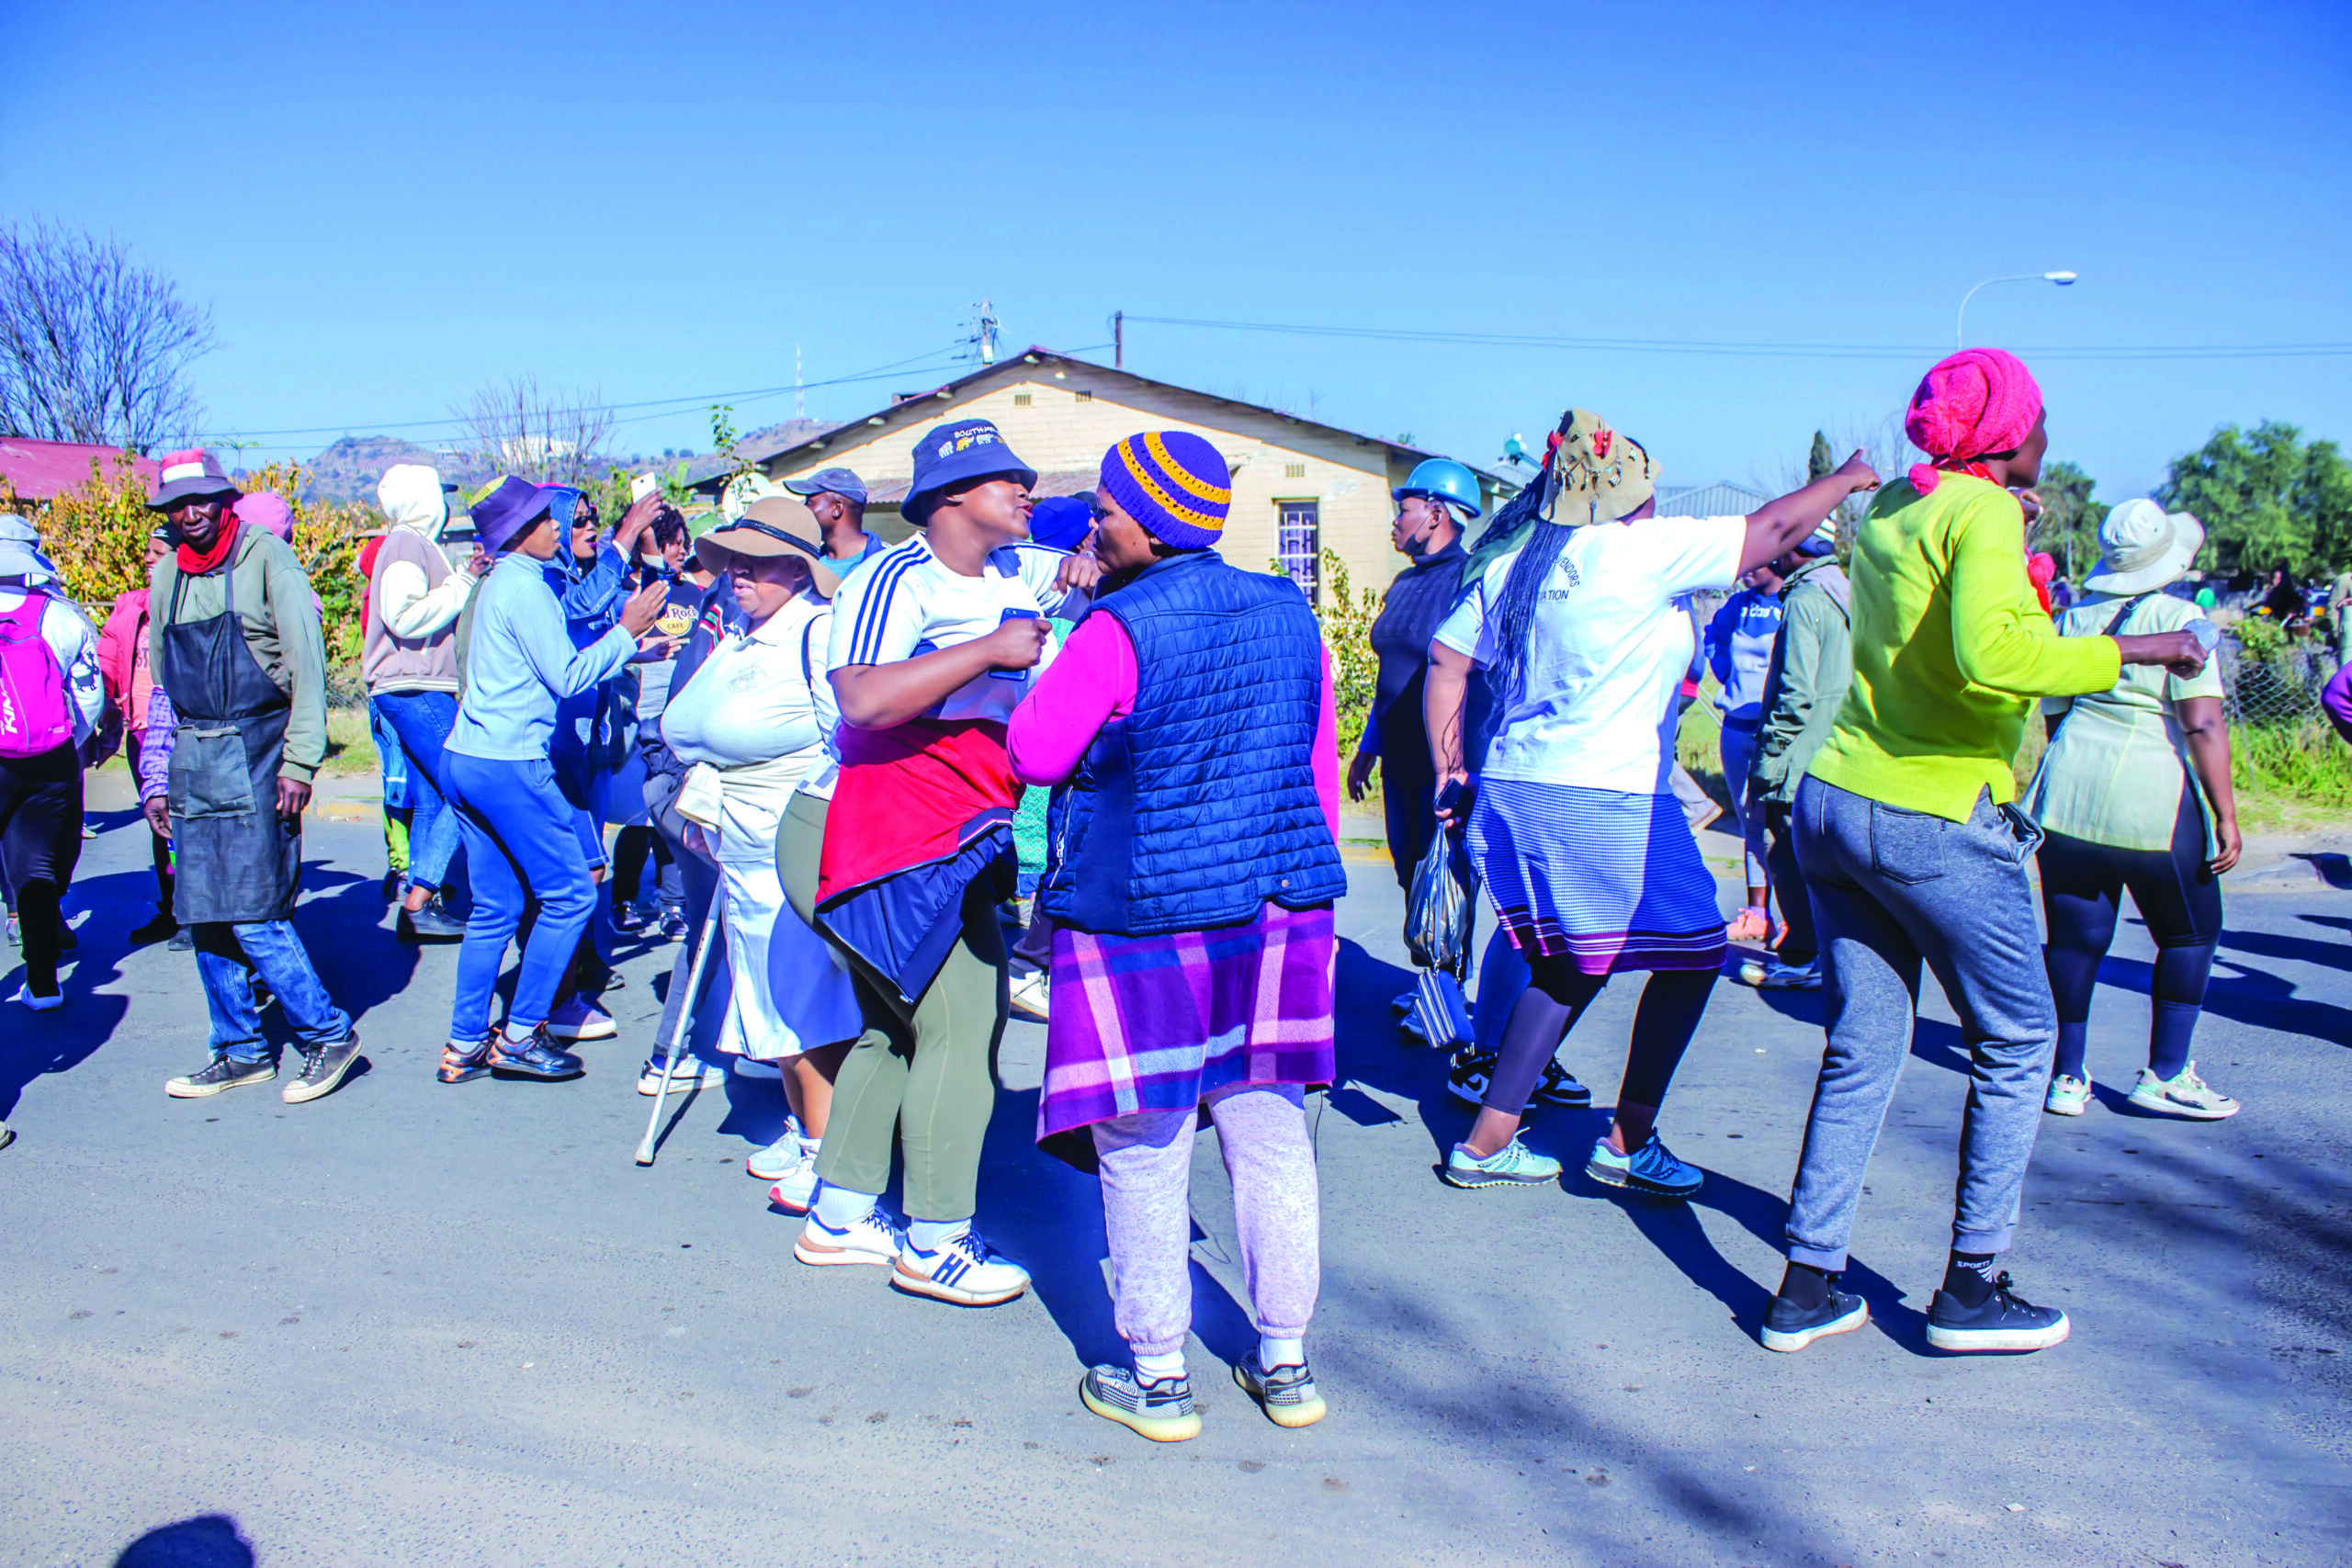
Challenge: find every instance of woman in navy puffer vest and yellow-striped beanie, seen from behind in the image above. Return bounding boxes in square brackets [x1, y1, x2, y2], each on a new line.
[1007, 430, 1348, 1441]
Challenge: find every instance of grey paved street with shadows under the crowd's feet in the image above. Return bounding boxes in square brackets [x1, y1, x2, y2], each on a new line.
[0, 790, 2352, 1568]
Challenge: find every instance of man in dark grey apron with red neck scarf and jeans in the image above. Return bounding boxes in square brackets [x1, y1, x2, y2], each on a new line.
[146, 451, 360, 1105]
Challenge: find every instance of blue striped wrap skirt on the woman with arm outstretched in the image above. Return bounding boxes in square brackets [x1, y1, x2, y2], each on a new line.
[1470, 778, 1726, 976]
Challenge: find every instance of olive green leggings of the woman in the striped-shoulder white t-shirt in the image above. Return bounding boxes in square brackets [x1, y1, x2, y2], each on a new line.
[795, 795, 1004, 1220]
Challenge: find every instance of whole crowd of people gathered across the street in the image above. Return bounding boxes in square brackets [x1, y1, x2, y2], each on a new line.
[0, 350, 2257, 1441]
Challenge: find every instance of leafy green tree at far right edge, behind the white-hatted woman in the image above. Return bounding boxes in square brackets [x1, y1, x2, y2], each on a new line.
[2157, 419, 2352, 576]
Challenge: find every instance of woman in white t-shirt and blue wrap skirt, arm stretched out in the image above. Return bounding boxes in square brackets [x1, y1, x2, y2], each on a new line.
[1425, 409, 1877, 1197]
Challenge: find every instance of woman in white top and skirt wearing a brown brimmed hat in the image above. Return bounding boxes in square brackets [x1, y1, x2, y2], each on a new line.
[661, 496, 864, 1211]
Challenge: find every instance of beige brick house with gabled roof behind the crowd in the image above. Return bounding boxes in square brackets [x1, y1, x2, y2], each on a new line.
[729, 348, 1515, 588]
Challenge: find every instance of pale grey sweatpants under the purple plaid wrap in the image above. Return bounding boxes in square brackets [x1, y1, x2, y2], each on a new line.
[1093, 1084, 1322, 1357]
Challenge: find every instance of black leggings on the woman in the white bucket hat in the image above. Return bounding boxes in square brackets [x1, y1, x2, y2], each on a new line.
[2041, 792, 2221, 1079]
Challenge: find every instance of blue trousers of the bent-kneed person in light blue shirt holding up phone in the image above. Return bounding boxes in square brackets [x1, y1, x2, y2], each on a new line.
[442, 752, 595, 1043]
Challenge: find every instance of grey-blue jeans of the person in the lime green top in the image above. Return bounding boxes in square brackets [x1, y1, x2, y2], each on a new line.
[1788, 778, 2058, 1272]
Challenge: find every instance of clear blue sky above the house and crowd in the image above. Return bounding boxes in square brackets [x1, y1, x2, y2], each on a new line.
[0, 0, 2352, 499]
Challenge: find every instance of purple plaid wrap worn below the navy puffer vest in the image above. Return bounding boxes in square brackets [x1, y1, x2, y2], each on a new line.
[1037, 903, 1339, 1143]
